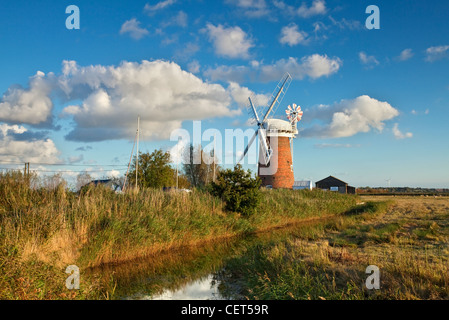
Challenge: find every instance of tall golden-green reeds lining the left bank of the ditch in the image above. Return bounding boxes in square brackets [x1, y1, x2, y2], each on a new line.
[0, 172, 356, 298]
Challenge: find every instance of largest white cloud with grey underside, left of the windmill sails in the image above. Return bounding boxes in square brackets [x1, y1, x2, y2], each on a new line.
[60, 60, 247, 141]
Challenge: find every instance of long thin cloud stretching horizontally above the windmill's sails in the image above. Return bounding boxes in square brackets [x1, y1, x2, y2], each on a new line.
[204, 54, 343, 82]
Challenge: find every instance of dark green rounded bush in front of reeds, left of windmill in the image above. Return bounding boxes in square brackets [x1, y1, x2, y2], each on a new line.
[211, 165, 261, 215]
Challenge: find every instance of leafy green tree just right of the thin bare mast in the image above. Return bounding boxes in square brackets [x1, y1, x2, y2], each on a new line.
[127, 149, 176, 188]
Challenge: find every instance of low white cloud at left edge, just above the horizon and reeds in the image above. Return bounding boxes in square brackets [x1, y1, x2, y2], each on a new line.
[0, 123, 61, 163]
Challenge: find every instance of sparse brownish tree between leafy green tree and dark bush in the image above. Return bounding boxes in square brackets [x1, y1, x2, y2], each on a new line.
[183, 145, 220, 188]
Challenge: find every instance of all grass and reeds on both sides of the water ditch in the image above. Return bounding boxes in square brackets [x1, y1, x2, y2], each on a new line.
[0, 170, 449, 299]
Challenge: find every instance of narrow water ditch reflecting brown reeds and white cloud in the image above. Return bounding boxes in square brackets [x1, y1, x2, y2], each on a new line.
[89, 221, 332, 300]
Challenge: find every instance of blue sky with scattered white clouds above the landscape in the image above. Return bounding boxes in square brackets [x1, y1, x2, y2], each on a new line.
[0, 0, 449, 187]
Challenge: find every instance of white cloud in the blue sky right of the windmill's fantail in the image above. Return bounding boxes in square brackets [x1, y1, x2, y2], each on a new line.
[300, 95, 399, 138]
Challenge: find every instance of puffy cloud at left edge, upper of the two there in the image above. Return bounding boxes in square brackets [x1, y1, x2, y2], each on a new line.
[0, 71, 53, 125]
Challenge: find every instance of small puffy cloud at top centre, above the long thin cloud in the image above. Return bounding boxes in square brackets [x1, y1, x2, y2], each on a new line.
[205, 23, 254, 59]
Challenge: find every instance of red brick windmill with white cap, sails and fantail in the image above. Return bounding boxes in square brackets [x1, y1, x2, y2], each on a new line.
[239, 73, 302, 189]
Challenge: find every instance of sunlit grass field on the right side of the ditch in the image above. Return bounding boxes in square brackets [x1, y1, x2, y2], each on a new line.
[221, 197, 449, 299]
